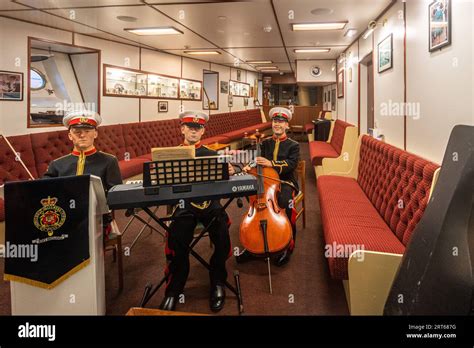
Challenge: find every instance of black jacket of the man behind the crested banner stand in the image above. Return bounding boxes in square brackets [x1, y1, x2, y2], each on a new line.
[44, 149, 122, 193]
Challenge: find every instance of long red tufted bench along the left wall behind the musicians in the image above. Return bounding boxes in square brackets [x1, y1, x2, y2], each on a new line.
[0, 109, 271, 222]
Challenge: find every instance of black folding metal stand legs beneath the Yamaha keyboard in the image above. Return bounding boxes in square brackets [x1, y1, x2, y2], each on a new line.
[140, 198, 244, 315]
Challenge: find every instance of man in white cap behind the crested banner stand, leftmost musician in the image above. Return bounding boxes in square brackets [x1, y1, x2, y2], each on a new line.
[44, 110, 122, 192]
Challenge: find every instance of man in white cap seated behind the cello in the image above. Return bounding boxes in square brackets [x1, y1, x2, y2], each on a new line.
[236, 107, 300, 266]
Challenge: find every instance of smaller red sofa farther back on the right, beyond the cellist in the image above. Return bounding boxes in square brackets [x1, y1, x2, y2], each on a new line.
[309, 120, 354, 166]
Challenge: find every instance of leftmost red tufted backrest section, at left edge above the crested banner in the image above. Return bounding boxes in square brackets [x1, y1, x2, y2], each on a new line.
[0, 134, 38, 185]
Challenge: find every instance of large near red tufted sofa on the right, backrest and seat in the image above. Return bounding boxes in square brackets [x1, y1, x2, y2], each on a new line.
[317, 135, 439, 279]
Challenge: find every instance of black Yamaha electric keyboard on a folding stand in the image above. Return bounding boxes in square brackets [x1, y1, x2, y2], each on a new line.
[107, 174, 257, 209]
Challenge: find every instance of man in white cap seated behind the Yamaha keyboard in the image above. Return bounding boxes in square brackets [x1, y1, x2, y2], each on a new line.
[160, 111, 234, 312]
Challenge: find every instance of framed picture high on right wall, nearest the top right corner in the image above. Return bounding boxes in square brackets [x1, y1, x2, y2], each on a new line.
[428, 0, 451, 52]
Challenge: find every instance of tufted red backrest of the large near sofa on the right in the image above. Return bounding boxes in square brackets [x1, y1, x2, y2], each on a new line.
[357, 136, 439, 245]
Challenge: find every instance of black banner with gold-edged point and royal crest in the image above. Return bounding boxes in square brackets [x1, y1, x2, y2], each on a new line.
[4, 175, 90, 289]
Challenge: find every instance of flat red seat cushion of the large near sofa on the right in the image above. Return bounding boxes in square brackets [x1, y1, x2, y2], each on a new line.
[317, 175, 405, 279]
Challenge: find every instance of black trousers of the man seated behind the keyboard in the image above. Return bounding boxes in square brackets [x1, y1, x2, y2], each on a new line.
[165, 202, 230, 296]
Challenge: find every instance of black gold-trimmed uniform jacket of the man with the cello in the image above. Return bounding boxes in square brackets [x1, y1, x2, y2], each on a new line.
[260, 135, 300, 190]
